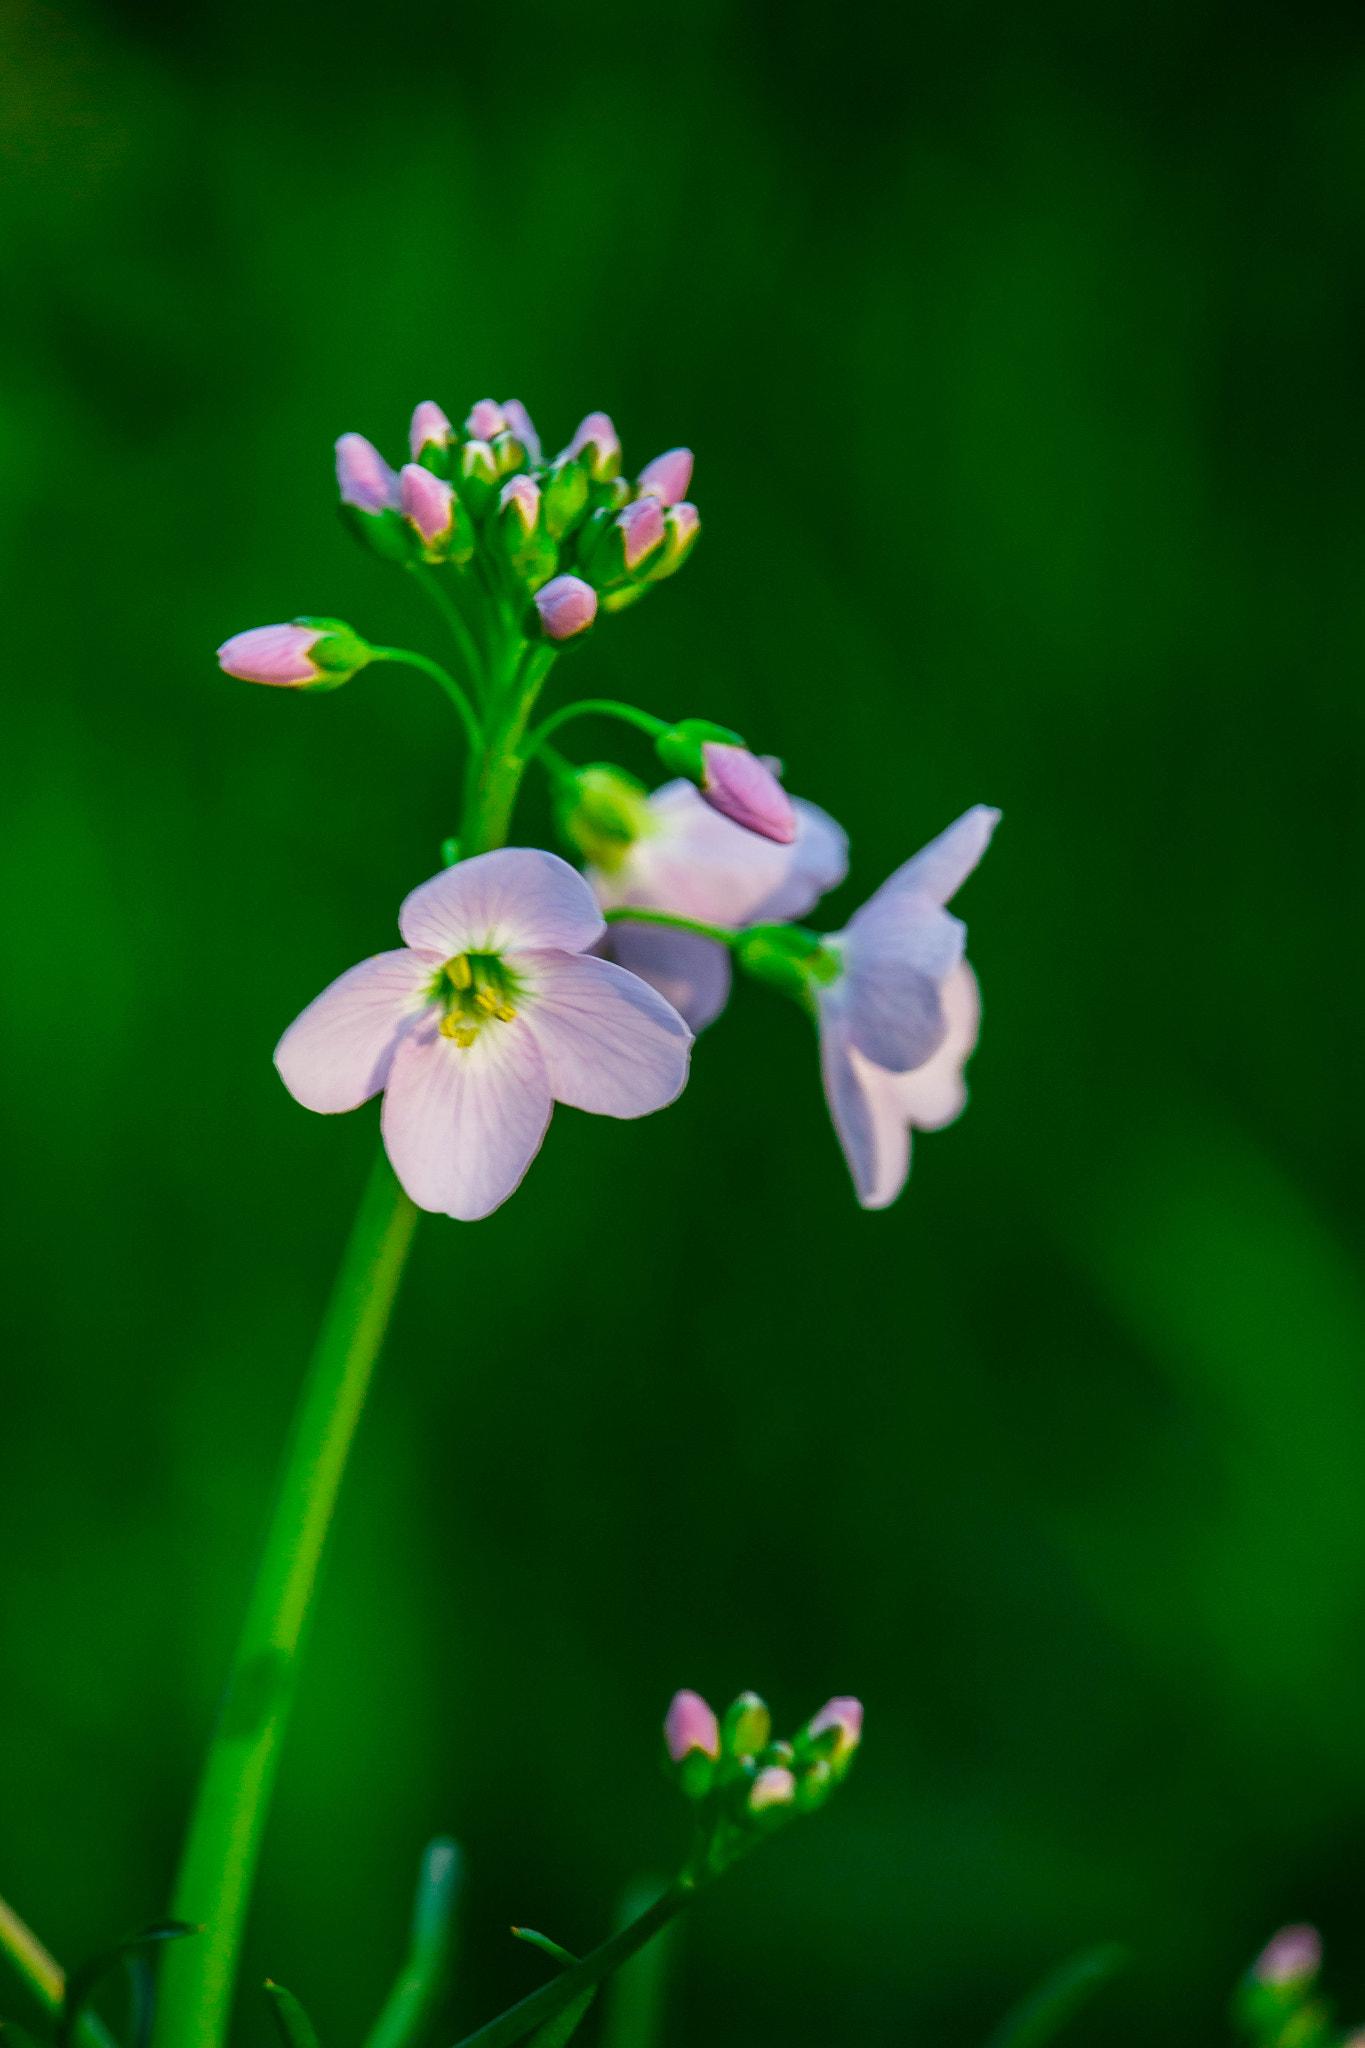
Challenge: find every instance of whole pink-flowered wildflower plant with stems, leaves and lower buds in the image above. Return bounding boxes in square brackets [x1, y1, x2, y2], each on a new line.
[0, 399, 999, 2048]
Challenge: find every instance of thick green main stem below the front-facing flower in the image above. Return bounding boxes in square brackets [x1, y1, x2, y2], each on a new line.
[156, 1153, 417, 2048]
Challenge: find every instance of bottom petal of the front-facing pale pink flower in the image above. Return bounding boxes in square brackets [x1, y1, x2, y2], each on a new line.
[383, 1016, 555, 1223]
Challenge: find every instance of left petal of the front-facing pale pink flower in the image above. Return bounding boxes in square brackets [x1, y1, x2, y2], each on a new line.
[274, 948, 438, 1116]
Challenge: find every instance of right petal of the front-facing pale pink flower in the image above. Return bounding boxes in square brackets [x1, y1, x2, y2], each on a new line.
[519, 952, 692, 1116]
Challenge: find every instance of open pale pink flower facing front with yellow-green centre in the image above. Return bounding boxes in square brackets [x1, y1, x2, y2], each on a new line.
[274, 848, 692, 1221]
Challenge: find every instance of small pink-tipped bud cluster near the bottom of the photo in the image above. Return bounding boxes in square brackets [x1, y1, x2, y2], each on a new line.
[663, 1692, 864, 1880]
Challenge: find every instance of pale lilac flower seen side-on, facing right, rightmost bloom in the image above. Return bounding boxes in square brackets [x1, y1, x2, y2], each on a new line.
[812, 803, 1001, 1208]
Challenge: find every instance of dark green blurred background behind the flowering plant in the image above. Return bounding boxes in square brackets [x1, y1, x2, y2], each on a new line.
[0, 0, 1365, 2048]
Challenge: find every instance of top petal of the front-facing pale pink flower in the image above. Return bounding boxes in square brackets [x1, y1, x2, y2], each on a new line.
[399, 846, 602, 958]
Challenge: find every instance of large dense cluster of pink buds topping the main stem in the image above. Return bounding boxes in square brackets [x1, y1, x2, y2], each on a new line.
[336, 397, 700, 641]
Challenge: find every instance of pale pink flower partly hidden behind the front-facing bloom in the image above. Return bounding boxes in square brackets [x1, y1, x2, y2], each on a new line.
[587, 780, 849, 1030]
